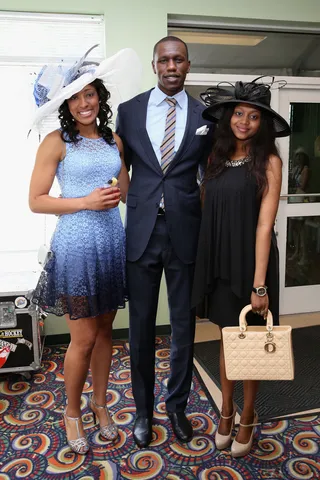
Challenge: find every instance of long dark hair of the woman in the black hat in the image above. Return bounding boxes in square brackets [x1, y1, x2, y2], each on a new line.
[204, 105, 279, 195]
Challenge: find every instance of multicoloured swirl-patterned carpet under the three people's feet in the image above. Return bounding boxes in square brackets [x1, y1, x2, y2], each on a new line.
[0, 337, 320, 480]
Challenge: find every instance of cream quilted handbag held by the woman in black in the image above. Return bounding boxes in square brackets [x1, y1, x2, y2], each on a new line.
[222, 305, 294, 380]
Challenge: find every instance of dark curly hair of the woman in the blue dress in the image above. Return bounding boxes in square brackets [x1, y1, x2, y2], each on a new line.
[59, 78, 114, 145]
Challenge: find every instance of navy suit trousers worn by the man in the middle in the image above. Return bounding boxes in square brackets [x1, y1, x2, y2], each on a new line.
[127, 215, 195, 418]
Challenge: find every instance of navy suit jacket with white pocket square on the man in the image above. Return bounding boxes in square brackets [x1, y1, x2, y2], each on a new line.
[117, 90, 213, 264]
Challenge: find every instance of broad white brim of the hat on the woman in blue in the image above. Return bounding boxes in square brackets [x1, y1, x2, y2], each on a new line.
[31, 48, 142, 129]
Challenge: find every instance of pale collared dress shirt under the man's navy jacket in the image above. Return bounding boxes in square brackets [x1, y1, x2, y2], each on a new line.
[146, 86, 188, 163]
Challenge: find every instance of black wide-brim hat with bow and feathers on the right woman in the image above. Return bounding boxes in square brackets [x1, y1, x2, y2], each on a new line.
[200, 77, 291, 137]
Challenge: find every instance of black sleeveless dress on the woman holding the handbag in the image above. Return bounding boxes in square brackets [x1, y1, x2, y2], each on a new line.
[192, 163, 279, 327]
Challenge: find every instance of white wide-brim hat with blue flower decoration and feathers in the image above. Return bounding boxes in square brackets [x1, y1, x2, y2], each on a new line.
[31, 45, 142, 130]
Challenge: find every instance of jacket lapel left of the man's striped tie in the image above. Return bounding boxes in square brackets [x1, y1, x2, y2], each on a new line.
[136, 90, 163, 175]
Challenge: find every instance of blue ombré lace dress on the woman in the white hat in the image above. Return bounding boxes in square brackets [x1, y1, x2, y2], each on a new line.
[33, 137, 127, 319]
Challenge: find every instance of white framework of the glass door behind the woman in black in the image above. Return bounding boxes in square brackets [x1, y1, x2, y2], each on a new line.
[185, 73, 320, 315]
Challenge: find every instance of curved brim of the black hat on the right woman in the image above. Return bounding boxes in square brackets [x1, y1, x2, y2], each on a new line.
[202, 99, 291, 137]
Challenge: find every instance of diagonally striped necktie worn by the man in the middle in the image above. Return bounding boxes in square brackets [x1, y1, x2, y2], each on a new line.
[160, 97, 177, 208]
